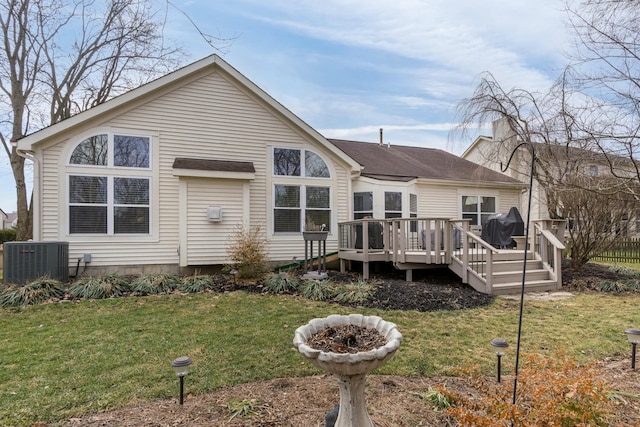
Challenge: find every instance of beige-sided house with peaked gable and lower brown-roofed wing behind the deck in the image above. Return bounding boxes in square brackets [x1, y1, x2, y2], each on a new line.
[17, 55, 523, 273]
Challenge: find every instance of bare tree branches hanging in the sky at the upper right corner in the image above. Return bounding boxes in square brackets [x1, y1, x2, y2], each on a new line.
[566, 0, 640, 182]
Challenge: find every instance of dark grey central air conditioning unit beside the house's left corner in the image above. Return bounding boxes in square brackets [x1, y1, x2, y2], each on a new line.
[3, 242, 69, 285]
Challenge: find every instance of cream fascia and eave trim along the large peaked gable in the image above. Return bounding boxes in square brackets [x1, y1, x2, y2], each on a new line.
[17, 54, 360, 171]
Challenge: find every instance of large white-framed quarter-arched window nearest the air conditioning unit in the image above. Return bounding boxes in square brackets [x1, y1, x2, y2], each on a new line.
[67, 133, 151, 235]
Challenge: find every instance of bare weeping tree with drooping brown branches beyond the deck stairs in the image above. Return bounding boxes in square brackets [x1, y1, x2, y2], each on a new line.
[458, 73, 638, 267]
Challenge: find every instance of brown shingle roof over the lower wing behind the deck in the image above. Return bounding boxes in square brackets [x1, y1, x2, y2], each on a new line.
[329, 139, 524, 185]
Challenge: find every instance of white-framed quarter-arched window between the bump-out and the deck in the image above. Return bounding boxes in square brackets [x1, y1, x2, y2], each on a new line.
[273, 148, 331, 233]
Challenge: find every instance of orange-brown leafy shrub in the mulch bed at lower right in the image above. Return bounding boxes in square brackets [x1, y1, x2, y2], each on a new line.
[446, 352, 617, 427]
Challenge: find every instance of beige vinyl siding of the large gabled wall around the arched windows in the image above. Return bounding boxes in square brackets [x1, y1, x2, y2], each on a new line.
[37, 67, 349, 266]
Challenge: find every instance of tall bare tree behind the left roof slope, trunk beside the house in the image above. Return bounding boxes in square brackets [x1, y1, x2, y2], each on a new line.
[0, 0, 228, 240]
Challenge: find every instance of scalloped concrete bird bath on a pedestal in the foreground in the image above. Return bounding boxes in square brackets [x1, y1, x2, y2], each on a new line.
[293, 314, 402, 427]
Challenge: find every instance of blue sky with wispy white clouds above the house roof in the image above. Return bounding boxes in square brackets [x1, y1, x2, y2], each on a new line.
[0, 0, 570, 212]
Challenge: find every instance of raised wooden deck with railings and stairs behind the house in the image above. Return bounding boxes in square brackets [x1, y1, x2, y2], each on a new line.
[338, 218, 564, 294]
